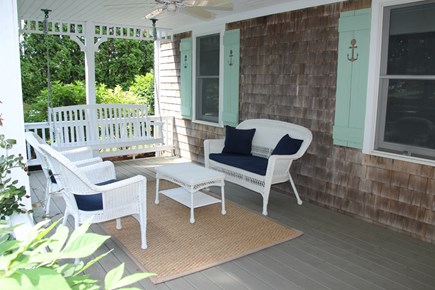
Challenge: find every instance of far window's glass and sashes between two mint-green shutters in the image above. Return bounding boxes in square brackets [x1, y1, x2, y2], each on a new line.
[195, 34, 220, 123]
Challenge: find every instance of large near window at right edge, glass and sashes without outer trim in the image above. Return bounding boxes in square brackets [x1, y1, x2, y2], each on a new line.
[375, 1, 435, 159]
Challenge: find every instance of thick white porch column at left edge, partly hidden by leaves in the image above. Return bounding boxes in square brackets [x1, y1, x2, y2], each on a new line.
[0, 0, 31, 239]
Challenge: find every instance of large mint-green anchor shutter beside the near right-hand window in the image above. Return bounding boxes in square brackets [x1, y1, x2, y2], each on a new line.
[333, 9, 371, 149]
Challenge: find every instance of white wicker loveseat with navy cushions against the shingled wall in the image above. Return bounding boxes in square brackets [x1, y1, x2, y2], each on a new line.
[204, 119, 313, 215]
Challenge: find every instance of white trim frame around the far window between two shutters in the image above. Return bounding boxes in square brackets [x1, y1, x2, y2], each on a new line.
[192, 24, 225, 127]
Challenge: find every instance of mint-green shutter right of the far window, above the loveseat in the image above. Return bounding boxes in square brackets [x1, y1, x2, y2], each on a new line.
[222, 29, 240, 126]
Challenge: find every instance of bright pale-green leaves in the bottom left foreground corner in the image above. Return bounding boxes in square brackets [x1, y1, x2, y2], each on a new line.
[0, 220, 152, 290]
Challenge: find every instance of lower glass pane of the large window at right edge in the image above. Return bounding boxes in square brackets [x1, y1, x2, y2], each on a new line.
[384, 80, 435, 149]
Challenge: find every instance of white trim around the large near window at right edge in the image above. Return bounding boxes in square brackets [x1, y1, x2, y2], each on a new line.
[363, 0, 435, 166]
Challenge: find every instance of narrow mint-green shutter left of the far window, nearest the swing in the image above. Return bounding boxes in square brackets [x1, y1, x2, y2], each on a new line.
[180, 38, 192, 119]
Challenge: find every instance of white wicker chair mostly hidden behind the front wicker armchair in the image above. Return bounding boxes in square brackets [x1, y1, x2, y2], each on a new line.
[25, 131, 103, 215]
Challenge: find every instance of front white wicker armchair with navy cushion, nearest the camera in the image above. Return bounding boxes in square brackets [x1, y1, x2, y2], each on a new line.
[39, 145, 147, 249]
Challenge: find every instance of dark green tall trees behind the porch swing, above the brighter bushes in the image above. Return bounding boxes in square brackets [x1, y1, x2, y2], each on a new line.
[20, 34, 154, 106]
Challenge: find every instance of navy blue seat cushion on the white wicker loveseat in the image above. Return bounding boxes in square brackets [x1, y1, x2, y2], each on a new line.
[209, 153, 268, 176]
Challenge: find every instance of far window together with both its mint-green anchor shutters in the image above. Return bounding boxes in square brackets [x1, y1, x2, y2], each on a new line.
[180, 29, 240, 126]
